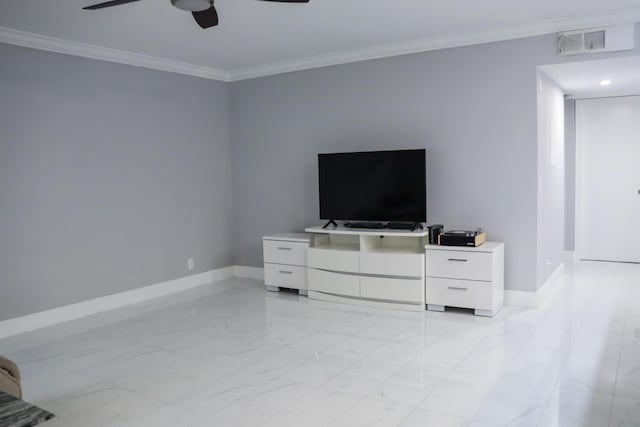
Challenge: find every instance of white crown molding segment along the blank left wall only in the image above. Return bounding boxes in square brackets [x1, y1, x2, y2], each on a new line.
[0, 27, 230, 82]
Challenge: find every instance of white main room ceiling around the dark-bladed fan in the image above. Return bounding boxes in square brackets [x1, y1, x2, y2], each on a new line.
[0, 0, 640, 79]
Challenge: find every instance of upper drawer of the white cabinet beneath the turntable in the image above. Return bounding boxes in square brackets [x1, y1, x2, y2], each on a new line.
[425, 250, 493, 282]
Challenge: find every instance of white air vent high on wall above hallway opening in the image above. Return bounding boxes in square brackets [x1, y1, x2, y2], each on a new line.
[558, 24, 634, 56]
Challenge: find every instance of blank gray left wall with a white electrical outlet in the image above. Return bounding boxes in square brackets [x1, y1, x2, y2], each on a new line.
[0, 44, 233, 320]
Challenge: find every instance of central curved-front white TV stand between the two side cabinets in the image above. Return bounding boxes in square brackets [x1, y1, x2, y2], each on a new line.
[305, 223, 429, 311]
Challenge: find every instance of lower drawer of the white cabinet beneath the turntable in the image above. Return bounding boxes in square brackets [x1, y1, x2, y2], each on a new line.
[425, 277, 492, 310]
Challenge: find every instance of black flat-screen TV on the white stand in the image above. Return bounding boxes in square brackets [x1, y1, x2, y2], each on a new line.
[318, 149, 427, 223]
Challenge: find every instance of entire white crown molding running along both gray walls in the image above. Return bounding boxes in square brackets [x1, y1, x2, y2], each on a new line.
[0, 7, 640, 82]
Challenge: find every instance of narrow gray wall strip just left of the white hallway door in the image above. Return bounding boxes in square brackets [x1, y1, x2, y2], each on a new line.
[564, 99, 576, 251]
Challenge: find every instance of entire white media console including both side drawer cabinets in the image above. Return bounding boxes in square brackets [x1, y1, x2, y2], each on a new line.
[263, 226, 504, 316]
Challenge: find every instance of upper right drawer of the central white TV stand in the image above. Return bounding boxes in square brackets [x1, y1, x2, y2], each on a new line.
[360, 252, 424, 277]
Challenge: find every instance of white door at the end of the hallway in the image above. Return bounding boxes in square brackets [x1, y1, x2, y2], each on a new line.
[575, 96, 640, 263]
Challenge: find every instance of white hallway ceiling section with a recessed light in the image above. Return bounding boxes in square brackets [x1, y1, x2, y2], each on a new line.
[540, 56, 640, 98]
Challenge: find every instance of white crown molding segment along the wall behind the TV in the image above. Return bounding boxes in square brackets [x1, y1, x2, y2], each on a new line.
[230, 8, 640, 81]
